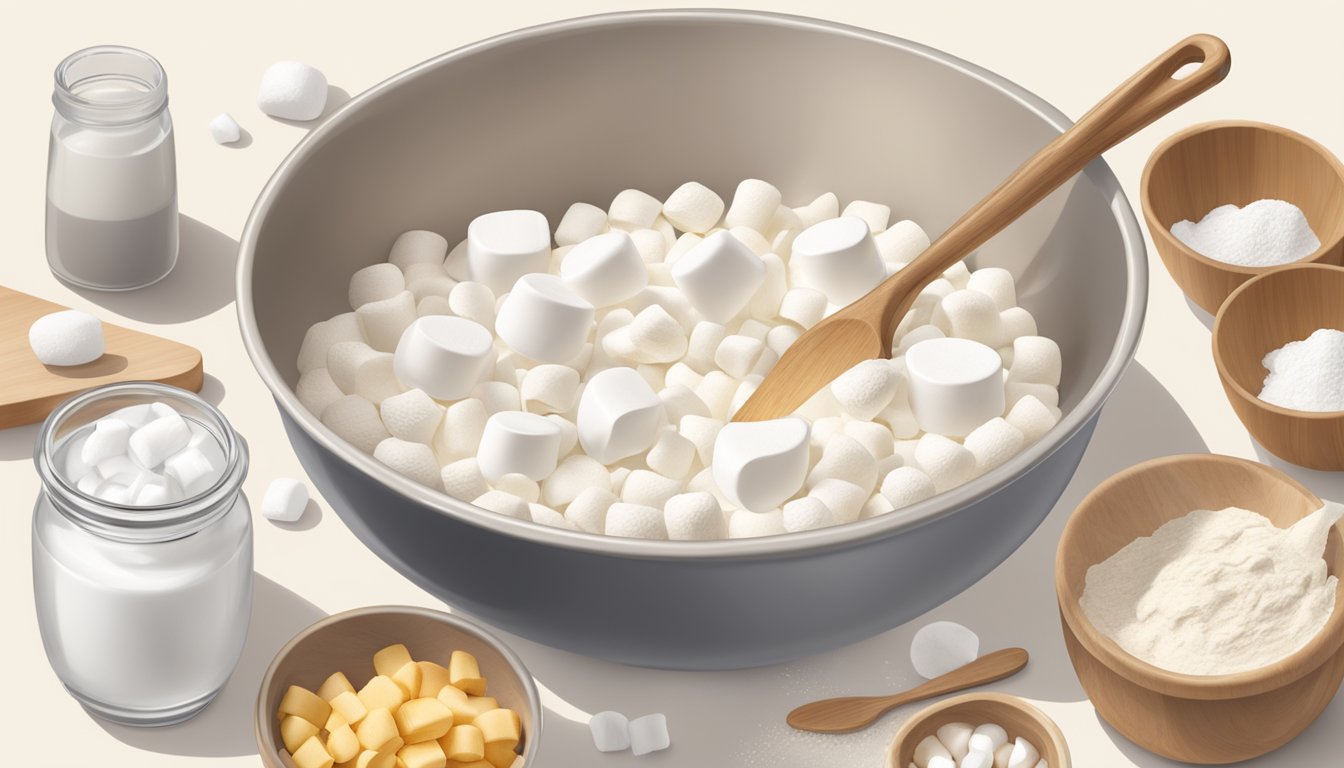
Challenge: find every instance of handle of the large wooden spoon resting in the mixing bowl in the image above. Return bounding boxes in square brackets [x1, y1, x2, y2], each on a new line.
[860, 35, 1232, 343]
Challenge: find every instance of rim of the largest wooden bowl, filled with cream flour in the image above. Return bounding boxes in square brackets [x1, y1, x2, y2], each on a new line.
[1055, 453, 1344, 699]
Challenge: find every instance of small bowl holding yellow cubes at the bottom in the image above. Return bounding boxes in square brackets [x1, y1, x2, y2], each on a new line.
[254, 605, 542, 768]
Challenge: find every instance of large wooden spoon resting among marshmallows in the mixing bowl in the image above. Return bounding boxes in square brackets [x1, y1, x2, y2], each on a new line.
[732, 35, 1231, 421]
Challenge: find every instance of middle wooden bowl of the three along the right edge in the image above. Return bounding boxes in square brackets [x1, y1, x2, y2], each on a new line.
[1214, 264, 1344, 471]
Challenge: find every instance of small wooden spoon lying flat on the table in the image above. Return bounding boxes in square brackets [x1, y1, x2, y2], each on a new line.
[785, 648, 1027, 733]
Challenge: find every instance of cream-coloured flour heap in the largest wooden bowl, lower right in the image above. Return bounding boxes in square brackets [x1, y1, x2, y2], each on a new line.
[1079, 503, 1344, 675]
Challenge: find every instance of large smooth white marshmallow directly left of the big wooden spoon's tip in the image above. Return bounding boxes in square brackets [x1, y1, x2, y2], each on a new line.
[578, 367, 663, 464]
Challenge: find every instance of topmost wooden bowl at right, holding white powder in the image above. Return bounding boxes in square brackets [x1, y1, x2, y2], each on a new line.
[1140, 120, 1344, 315]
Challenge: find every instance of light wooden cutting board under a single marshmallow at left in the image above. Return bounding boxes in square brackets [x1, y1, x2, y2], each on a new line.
[0, 285, 204, 429]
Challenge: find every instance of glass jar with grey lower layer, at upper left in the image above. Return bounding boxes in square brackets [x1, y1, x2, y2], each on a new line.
[47, 46, 177, 291]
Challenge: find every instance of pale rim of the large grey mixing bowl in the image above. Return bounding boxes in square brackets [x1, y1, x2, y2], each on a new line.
[235, 4, 1148, 561]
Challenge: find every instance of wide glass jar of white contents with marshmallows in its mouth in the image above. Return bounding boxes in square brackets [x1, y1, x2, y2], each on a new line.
[32, 382, 253, 725]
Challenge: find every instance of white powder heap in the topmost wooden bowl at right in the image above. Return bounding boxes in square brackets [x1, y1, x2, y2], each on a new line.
[1172, 200, 1321, 266]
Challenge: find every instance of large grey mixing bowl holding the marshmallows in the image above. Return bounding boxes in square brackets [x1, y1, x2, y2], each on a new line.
[238, 11, 1146, 668]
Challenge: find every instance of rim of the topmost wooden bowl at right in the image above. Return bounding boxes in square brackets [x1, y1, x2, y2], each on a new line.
[1138, 120, 1344, 277]
